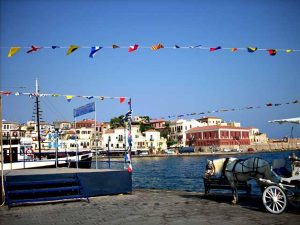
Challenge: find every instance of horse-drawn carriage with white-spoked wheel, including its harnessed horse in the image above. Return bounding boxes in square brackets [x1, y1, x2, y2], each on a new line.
[203, 155, 300, 214]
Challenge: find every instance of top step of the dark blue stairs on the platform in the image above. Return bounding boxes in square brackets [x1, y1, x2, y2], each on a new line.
[6, 178, 77, 187]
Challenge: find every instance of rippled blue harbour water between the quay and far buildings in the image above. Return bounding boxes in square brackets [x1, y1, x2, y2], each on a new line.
[92, 150, 300, 194]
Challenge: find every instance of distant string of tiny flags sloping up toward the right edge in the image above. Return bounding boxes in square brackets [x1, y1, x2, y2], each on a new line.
[152, 100, 299, 119]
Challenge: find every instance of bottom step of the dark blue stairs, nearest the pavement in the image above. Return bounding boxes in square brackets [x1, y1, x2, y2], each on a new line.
[8, 195, 89, 206]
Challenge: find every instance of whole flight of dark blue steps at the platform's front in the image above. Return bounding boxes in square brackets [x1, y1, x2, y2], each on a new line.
[4, 174, 89, 207]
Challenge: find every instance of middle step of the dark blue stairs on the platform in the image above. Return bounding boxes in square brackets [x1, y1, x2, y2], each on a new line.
[7, 186, 81, 196]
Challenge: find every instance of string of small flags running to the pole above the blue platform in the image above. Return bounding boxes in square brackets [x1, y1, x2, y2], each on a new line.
[0, 91, 131, 105]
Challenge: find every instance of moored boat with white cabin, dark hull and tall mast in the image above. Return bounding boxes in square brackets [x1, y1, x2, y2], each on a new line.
[0, 80, 93, 170]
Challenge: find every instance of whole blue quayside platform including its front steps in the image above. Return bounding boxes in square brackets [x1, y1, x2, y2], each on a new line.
[1, 168, 132, 205]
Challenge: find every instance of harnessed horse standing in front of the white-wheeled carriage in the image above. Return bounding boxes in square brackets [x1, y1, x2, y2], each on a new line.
[205, 157, 280, 204]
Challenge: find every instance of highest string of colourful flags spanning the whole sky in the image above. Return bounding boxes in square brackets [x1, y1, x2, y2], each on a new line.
[1, 43, 300, 58]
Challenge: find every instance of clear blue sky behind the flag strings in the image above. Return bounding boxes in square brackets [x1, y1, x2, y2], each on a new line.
[0, 0, 300, 137]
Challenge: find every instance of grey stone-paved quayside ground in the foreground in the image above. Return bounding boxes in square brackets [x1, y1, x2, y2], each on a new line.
[0, 190, 300, 225]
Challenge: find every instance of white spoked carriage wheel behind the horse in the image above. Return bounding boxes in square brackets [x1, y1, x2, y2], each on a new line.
[262, 186, 287, 214]
